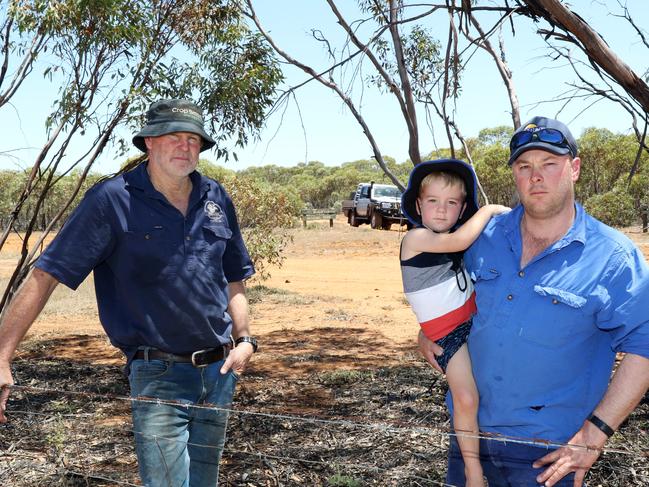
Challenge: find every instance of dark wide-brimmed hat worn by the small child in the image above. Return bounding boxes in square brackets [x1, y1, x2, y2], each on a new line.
[401, 159, 479, 228]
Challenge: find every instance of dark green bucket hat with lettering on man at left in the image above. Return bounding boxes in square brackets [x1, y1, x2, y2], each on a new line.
[133, 100, 216, 152]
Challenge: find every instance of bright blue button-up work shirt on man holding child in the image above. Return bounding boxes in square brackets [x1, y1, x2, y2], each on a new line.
[465, 205, 649, 442]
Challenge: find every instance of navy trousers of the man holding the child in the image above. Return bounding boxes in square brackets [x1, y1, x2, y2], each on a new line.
[446, 436, 586, 487]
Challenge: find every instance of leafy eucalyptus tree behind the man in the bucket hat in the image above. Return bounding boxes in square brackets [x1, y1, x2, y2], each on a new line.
[0, 0, 282, 310]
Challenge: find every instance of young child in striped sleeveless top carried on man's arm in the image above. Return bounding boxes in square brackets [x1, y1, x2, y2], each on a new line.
[400, 159, 509, 487]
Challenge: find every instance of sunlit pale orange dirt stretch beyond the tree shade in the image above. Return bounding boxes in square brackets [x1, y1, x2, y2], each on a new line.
[0, 215, 649, 367]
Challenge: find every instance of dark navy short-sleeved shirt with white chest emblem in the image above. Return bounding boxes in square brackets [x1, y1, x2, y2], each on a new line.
[36, 163, 254, 360]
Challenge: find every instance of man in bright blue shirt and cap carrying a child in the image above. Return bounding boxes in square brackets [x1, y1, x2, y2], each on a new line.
[420, 117, 649, 487]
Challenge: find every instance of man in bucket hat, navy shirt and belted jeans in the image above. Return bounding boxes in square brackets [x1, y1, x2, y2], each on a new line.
[0, 100, 257, 487]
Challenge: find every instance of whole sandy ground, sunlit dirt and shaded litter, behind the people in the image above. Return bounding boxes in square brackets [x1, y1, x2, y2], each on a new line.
[0, 224, 649, 487]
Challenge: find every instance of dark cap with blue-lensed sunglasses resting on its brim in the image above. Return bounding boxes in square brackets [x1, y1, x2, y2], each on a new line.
[509, 117, 577, 166]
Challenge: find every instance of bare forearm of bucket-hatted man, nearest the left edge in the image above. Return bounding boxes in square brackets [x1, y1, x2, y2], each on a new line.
[0, 269, 58, 362]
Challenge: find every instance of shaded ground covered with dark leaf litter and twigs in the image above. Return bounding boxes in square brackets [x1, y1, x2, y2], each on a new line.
[0, 329, 649, 487]
